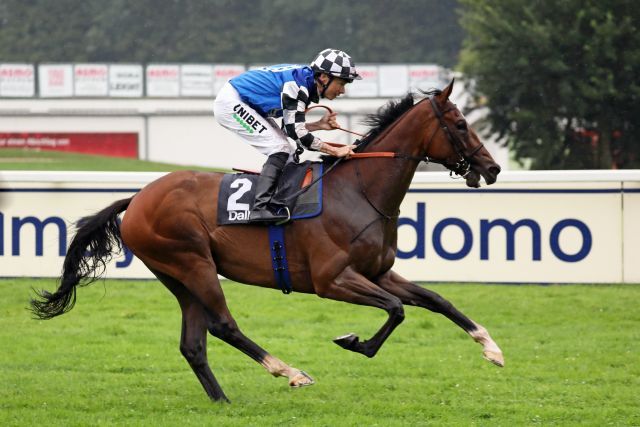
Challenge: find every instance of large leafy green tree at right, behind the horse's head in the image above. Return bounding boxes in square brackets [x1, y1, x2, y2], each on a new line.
[460, 0, 640, 169]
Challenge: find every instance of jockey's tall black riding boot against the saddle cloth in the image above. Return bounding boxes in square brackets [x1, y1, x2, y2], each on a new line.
[249, 152, 289, 224]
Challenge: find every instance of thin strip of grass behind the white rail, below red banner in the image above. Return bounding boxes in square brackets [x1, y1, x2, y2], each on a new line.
[0, 149, 225, 172]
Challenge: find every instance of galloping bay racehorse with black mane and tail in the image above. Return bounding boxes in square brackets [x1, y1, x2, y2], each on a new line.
[31, 81, 504, 401]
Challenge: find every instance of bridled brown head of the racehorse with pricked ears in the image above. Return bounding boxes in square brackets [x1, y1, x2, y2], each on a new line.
[423, 80, 500, 188]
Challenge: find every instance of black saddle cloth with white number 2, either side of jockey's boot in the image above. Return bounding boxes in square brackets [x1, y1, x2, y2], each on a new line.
[218, 161, 322, 225]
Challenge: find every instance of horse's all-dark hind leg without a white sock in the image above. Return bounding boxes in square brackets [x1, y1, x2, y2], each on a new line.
[153, 271, 229, 402]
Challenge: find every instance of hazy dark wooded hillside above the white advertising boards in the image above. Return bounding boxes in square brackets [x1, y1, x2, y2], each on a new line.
[0, 0, 463, 67]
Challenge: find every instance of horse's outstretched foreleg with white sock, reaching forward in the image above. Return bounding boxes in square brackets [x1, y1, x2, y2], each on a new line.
[377, 271, 504, 367]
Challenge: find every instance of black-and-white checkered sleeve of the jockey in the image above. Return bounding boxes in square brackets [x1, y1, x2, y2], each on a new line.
[281, 81, 322, 151]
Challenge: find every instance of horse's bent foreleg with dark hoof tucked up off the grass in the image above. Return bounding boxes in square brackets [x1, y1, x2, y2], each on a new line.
[315, 267, 404, 357]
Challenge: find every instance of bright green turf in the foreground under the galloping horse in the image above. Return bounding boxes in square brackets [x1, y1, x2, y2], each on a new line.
[0, 279, 640, 426]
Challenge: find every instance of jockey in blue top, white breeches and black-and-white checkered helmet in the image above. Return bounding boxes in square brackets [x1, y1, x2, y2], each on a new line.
[213, 49, 361, 223]
